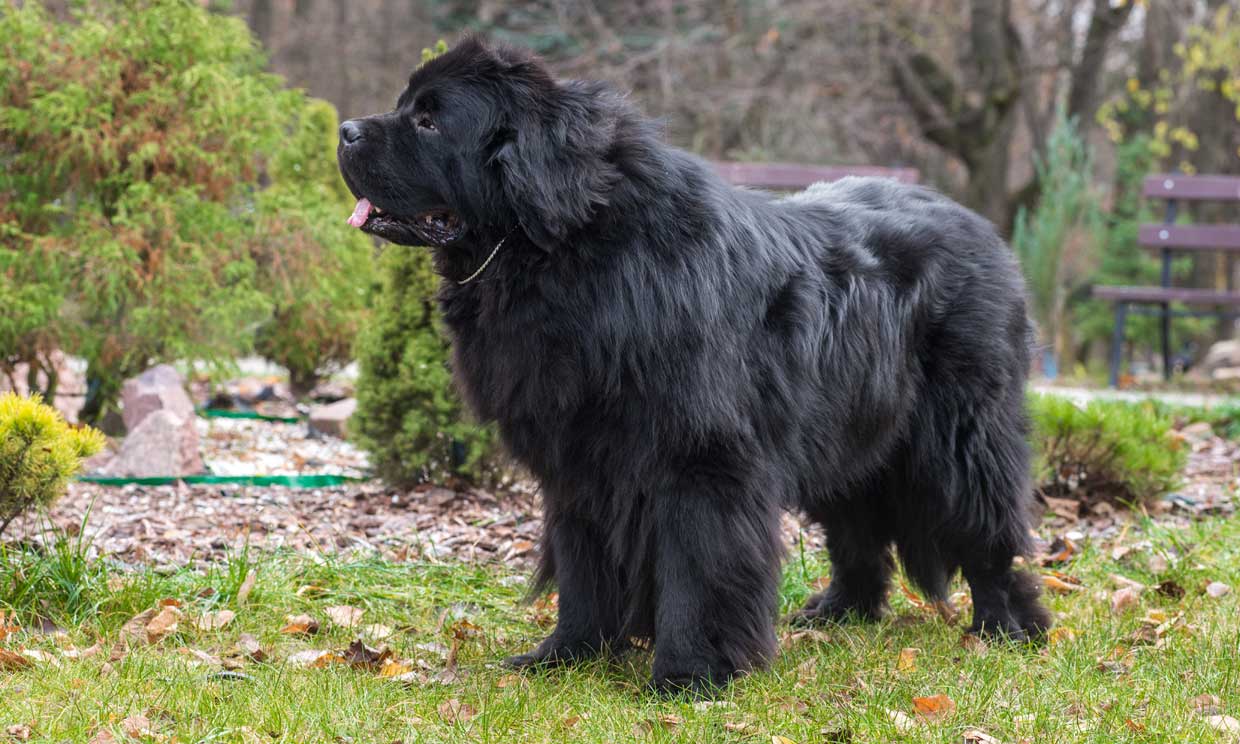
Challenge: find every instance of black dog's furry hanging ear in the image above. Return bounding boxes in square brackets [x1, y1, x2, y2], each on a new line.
[494, 58, 619, 250]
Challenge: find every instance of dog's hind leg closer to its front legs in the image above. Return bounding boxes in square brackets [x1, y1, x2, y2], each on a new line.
[791, 487, 893, 625]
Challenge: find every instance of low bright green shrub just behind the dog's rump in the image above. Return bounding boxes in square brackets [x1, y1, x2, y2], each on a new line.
[1029, 394, 1188, 505]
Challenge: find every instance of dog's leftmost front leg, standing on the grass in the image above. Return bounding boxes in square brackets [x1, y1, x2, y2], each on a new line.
[505, 513, 624, 668]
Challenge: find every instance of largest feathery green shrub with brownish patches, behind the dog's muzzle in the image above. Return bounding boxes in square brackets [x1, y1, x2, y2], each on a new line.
[0, 0, 371, 422]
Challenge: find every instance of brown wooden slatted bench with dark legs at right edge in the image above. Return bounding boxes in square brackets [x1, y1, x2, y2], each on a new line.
[1094, 174, 1240, 387]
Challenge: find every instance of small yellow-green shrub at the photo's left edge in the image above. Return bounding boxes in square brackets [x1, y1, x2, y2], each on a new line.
[0, 393, 105, 533]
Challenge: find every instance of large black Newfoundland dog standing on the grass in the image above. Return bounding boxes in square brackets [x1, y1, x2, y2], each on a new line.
[339, 38, 1049, 691]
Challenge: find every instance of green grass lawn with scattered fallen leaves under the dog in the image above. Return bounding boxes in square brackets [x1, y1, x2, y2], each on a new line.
[0, 520, 1240, 744]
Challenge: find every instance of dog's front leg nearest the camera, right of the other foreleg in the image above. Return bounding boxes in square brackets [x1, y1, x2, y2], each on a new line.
[652, 479, 782, 694]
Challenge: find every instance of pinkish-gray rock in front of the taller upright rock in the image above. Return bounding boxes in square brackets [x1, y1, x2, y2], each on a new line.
[103, 410, 202, 477]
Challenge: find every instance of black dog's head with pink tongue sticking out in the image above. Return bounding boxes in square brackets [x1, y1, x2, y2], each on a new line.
[337, 38, 619, 252]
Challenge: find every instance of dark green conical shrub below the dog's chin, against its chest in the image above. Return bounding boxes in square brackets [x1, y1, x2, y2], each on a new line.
[348, 246, 496, 486]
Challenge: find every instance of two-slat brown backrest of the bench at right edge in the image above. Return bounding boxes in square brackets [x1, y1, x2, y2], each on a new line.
[1137, 174, 1240, 252]
